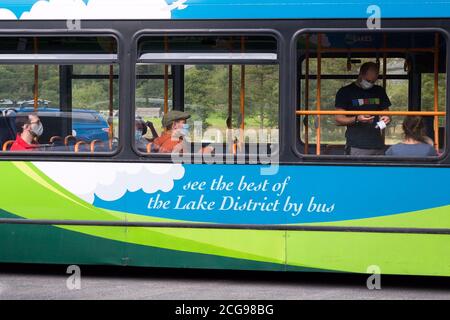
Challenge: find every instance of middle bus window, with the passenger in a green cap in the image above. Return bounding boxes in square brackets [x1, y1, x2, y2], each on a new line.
[136, 36, 279, 162]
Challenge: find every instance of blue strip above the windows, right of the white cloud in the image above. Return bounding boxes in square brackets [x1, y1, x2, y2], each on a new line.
[172, 0, 450, 19]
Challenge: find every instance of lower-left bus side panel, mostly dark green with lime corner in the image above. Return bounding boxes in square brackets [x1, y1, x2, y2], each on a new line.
[0, 224, 125, 265]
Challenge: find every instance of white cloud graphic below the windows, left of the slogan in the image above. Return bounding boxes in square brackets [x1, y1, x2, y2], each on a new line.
[33, 162, 184, 203]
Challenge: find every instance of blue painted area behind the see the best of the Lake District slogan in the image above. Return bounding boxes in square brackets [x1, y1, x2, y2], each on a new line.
[94, 165, 450, 224]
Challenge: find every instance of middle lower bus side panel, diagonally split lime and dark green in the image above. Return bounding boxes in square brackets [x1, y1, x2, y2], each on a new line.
[127, 227, 286, 271]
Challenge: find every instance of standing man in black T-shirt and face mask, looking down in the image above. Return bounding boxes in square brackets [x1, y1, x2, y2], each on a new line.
[335, 62, 391, 156]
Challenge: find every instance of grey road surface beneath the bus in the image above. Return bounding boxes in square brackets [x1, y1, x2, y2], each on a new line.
[0, 264, 450, 300]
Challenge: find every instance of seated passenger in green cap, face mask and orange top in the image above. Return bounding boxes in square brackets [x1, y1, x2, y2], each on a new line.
[153, 110, 191, 153]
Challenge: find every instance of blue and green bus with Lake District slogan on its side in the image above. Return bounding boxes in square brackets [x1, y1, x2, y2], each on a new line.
[0, 0, 450, 276]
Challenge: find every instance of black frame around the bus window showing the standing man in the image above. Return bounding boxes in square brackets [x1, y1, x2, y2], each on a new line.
[290, 27, 450, 165]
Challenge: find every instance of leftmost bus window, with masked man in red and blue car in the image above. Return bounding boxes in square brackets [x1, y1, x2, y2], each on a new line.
[0, 37, 119, 153]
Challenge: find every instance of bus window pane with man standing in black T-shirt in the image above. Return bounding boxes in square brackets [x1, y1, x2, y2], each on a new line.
[297, 32, 447, 157]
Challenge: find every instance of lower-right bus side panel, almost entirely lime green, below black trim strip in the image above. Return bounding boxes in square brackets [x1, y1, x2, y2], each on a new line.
[287, 231, 450, 276]
